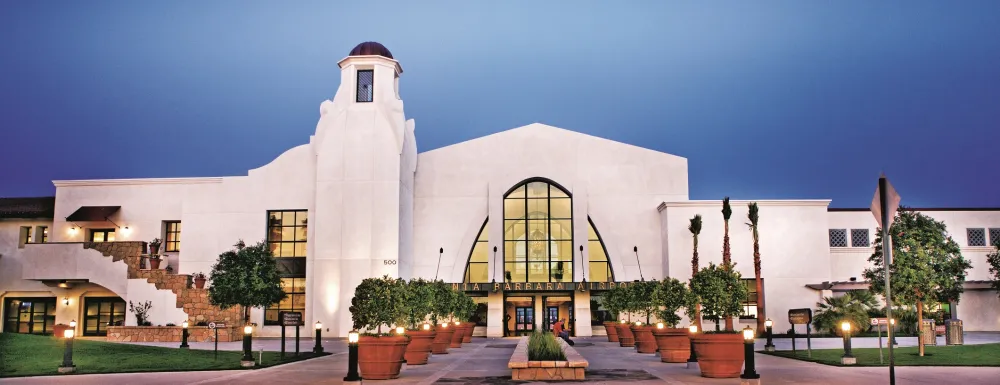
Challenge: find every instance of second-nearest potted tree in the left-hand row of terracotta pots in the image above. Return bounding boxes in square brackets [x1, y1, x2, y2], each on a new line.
[404, 278, 436, 365]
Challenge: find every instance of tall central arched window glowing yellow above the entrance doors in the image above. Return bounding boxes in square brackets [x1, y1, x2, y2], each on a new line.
[503, 179, 573, 282]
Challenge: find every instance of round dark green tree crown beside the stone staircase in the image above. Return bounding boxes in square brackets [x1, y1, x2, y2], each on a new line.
[208, 240, 285, 321]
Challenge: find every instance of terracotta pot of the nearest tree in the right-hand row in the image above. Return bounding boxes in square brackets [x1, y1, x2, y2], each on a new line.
[694, 333, 743, 378]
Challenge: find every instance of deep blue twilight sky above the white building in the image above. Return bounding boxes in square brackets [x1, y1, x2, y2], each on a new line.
[0, 0, 1000, 207]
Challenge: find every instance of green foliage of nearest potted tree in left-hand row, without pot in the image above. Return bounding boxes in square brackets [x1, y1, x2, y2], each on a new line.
[350, 275, 410, 334]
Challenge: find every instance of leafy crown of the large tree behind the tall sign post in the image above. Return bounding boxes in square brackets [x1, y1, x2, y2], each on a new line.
[864, 207, 972, 305]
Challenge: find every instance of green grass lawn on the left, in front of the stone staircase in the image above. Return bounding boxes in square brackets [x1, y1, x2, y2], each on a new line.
[0, 333, 326, 377]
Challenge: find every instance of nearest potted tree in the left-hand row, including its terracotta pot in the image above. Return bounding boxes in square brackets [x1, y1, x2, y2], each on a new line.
[350, 275, 410, 380]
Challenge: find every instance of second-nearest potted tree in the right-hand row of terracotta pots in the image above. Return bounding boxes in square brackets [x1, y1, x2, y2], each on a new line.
[653, 278, 697, 362]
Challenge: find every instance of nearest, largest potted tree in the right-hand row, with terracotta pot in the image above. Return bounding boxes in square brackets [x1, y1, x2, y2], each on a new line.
[687, 263, 747, 378]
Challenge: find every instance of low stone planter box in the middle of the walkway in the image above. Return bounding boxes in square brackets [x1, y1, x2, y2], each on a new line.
[507, 337, 590, 381]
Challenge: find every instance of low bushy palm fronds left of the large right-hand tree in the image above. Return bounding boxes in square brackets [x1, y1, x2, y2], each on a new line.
[813, 290, 878, 334]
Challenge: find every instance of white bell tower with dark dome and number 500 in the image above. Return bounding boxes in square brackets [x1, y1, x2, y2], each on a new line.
[307, 42, 417, 336]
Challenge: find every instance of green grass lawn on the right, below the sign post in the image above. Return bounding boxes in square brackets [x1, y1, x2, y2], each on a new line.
[759, 344, 1000, 366]
